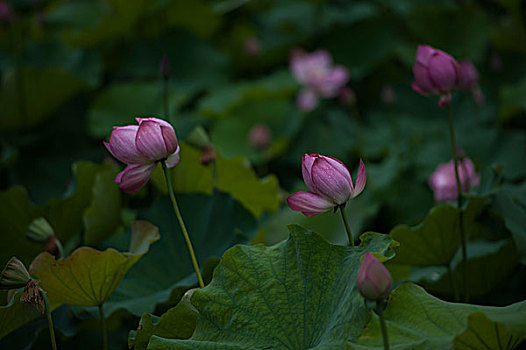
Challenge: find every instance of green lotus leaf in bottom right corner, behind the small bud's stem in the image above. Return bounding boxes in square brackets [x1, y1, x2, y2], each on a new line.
[348, 283, 526, 350]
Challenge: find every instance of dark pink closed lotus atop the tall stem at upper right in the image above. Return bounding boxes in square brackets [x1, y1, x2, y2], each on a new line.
[411, 45, 461, 107]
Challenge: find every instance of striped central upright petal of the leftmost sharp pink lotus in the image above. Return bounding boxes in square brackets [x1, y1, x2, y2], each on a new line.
[135, 120, 169, 162]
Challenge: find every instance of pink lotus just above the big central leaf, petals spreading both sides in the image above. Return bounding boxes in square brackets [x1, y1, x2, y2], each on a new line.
[287, 154, 367, 216]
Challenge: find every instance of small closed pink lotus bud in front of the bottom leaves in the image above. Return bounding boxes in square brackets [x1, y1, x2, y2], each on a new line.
[356, 252, 393, 301]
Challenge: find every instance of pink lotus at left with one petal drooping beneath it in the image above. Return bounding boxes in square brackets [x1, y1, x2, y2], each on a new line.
[104, 118, 179, 193]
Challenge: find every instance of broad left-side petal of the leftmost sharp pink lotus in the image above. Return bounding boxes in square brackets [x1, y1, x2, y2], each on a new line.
[104, 125, 148, 164]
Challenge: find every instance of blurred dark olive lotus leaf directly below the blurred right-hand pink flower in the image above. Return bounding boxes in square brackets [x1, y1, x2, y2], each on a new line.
[390, 197, 487, 266]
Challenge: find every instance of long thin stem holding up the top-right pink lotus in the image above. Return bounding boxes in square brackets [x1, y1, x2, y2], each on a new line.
[447, 106, 469, 302]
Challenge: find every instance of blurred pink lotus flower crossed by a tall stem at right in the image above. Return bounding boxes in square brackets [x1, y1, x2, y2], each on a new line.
[429, 158, 480, 202]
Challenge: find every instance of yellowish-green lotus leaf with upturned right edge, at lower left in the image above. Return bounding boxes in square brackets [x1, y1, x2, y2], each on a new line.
[29, 221, 159, 306]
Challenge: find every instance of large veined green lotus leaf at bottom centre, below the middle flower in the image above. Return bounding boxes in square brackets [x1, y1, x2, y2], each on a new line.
[149, 225, 394, 350]
